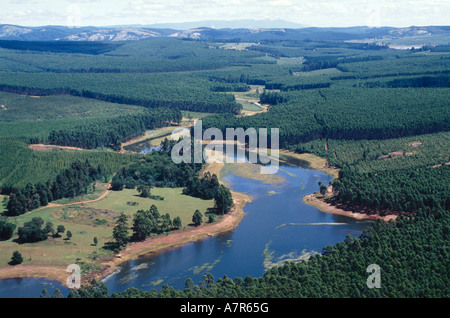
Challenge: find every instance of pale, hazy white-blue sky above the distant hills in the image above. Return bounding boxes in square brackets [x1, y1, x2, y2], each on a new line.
[0, 0, 450, 27]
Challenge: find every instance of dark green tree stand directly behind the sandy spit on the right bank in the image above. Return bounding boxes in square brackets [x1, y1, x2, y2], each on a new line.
[331, 165, 450, 213]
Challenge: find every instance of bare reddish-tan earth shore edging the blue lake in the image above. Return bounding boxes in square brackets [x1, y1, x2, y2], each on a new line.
[0, 149, 397, 285]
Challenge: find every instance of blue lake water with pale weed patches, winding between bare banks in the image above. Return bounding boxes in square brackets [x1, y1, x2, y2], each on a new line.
[0, 145, 371, 297]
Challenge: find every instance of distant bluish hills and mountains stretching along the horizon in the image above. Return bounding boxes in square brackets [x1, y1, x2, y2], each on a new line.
[0, 20, 450, 44]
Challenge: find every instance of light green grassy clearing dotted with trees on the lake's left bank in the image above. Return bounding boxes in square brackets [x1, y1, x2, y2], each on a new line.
[0, 186, 214, 276]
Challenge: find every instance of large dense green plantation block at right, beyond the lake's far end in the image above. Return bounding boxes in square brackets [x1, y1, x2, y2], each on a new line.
[202, 87, 450, 147]
